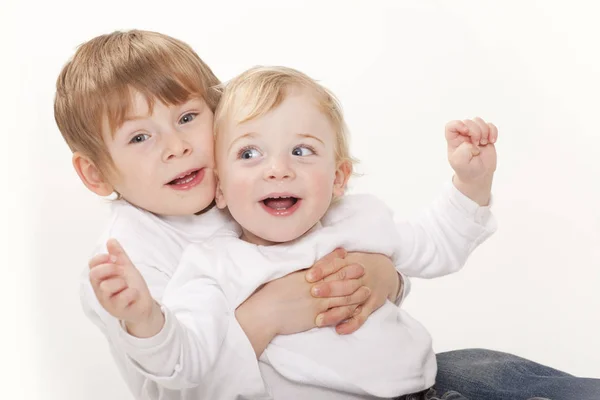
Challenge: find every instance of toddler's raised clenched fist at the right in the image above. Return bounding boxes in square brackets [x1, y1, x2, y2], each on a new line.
[446, 117, 498, 206]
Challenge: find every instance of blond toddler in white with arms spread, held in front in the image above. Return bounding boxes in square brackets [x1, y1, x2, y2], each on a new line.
[94, 68, 497, 399]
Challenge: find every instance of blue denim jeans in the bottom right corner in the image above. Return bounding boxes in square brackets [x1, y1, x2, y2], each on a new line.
[418, 349, 600, 400]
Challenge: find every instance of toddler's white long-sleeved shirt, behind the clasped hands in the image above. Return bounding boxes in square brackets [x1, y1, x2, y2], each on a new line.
[106, 185, 495, 399]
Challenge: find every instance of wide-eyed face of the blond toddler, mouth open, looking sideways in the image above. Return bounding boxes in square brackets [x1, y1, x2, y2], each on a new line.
[217, 89, 346, 245]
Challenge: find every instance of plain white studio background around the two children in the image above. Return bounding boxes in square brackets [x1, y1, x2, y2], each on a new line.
[0, 0, 600, 400]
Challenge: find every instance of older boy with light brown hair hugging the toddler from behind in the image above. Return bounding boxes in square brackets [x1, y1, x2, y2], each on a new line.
[55, 31, 492, 399]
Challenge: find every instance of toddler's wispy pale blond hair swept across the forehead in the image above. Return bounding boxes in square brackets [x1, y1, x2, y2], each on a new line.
[214, 66, 357, 163]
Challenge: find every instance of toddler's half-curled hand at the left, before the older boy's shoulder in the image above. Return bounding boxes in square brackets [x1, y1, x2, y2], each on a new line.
[89, 239, 164, 337]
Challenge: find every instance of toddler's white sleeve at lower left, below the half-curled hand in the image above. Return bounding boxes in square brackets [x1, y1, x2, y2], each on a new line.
[112, 245, 262, 389]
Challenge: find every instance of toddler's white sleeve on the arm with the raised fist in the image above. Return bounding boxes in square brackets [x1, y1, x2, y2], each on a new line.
[323, 183, 496, 284]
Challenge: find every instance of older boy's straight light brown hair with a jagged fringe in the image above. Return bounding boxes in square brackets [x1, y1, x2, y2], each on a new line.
[54, 30, 220, 171]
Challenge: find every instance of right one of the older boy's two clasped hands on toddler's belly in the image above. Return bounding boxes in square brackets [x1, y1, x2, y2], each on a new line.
[311, 253, 402, 334]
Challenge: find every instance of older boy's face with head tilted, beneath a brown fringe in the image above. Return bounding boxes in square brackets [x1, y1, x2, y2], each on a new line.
[103, 93, 215, 215]
